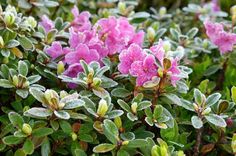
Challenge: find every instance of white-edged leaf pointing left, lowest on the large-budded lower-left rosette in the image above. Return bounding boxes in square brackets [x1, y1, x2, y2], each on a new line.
[24, 107, 52, 118]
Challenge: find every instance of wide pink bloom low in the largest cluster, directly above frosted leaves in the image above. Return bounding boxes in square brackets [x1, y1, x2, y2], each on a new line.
[65, 43, 99, 65]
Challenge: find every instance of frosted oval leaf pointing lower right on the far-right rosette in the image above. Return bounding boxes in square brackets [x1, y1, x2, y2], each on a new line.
[205, 114, 227, 127]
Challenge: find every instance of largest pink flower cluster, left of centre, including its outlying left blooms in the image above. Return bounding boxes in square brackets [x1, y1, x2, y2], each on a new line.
[40, 7, 144, 80]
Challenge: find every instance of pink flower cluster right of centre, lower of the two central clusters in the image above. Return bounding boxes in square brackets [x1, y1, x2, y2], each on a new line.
[118, 41, 181, 86]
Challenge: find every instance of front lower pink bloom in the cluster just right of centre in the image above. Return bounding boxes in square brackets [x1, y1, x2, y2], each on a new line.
[130, 55, 157, 86]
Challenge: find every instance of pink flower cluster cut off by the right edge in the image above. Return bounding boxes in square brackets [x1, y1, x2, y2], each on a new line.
[204, 21, 236, 54]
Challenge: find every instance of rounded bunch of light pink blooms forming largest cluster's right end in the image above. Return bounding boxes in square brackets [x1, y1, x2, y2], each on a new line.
[94, 16, 144, 55]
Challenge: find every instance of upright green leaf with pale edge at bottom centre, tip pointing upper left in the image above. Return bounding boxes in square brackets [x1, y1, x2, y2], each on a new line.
[103, 119, 119, 144]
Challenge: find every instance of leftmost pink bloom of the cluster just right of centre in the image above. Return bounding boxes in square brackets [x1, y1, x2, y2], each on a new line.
[118, 43, 146, 74]
